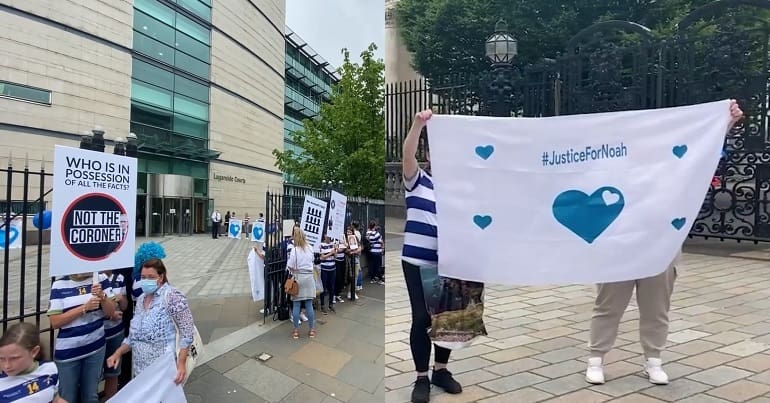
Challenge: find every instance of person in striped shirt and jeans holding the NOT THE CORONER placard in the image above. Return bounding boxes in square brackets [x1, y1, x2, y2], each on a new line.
[48, 273, 115, 403]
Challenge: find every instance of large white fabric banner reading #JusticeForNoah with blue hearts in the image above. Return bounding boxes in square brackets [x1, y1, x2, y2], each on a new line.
[428, 101, 730, 285]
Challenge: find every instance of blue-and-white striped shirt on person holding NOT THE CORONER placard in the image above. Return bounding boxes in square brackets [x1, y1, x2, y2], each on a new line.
[48, 273, 112, 362]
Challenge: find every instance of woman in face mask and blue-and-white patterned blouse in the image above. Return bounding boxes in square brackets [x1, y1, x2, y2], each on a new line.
[107, 244, 195, 385]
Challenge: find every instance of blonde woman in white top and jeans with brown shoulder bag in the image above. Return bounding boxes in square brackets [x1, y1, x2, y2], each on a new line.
[286, 226, 316, 340]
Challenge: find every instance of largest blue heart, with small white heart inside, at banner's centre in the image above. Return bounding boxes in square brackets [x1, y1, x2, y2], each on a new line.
[552, 186, 625, 243]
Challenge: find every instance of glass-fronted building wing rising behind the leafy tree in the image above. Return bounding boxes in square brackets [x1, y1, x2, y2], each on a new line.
[283, 28, 338, 182]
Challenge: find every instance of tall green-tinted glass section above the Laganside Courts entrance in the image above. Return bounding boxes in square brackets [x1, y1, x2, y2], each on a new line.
[131, 0, 216, 196]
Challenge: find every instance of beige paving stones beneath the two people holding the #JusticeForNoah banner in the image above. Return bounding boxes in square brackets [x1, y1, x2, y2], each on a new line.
[385, 240, 770, 403]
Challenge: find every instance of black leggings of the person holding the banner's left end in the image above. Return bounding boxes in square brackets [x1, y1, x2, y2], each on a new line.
[401, 260, 452, 372]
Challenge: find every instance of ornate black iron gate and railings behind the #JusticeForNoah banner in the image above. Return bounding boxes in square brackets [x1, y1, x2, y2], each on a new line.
[386, 0, 770, 242]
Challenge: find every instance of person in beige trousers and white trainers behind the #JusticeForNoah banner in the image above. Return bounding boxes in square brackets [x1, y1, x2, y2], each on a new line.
[585, 100, 743, 385]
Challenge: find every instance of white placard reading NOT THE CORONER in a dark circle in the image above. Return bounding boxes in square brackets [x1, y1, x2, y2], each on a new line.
[51, 145, 137, 276]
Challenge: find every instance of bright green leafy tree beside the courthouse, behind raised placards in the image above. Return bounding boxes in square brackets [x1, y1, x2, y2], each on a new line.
[273, 43, 385, 199]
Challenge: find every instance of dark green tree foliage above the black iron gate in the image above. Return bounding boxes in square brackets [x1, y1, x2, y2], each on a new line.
[395, 0, 709, 78]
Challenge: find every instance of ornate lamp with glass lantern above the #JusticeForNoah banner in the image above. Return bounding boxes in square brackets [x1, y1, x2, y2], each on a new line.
[482, 20, 518, 117]
